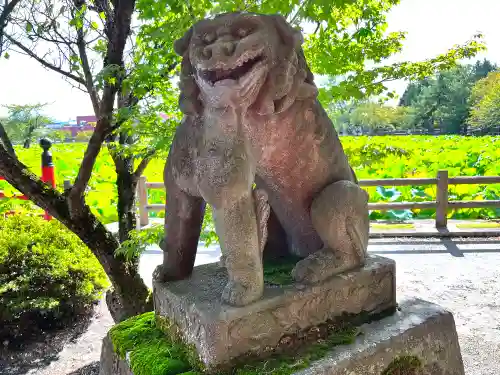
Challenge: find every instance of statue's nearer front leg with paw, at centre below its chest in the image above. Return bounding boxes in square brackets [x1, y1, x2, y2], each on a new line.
[199, 146, 264, 306]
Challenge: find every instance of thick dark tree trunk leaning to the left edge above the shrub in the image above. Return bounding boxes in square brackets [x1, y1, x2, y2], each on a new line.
[0, 147, 153, 321]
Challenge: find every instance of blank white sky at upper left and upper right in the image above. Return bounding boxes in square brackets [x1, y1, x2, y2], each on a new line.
[0, 0, 500, 120]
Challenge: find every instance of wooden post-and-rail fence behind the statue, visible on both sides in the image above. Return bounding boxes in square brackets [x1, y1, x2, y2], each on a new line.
[137, 170, 500, 229]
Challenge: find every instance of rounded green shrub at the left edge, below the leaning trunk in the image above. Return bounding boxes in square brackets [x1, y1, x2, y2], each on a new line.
[0, 215, 108, 342]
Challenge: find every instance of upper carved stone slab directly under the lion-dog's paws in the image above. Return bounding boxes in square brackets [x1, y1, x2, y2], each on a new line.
[153, 256, 396, 367]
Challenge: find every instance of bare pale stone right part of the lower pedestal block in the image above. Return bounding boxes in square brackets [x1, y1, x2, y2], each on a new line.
[295, 299, 464, 375]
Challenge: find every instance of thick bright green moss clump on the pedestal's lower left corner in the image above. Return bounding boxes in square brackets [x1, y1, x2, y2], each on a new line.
[109, 312, 203, 375]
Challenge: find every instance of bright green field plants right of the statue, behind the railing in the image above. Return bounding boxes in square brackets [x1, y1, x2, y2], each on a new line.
[350, 136, 500, 220]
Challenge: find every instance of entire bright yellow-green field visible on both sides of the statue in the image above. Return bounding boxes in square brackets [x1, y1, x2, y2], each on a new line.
[0, 136, 500, 223]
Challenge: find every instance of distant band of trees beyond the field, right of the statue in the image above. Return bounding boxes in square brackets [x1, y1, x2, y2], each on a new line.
[328, 59, 500, 135]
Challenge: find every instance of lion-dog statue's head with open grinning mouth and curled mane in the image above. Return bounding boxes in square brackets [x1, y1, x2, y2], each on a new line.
[174, 13, 317, 115]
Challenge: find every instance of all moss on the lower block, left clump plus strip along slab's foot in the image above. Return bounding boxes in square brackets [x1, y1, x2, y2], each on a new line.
[110, 312, 359, 375]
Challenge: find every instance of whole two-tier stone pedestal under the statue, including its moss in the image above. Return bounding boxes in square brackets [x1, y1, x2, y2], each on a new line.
[100, 255, 464, 375]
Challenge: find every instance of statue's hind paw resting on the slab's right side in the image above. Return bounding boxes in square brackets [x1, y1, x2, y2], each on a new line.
[292, 249, 359, 284]
